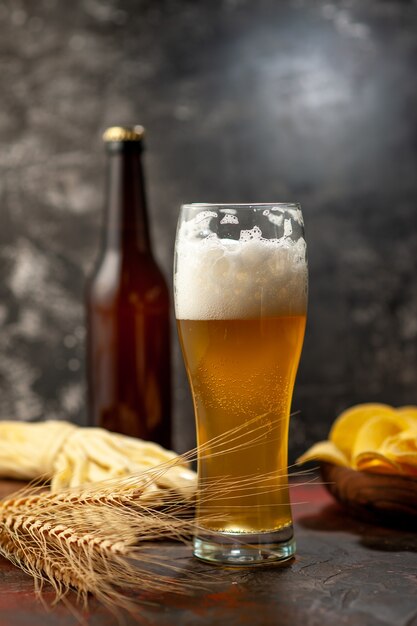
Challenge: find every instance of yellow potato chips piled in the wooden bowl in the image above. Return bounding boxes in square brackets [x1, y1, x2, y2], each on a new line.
[297, 403, 417, 476]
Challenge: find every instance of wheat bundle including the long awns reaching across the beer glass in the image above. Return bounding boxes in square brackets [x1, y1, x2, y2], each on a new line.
[0, 416, 312, 609]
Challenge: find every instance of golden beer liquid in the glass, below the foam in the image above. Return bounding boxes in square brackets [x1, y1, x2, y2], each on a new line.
[178, 315, 305, 533]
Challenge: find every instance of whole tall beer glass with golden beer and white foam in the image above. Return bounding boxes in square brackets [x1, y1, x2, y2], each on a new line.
[174, 204, 307, 565]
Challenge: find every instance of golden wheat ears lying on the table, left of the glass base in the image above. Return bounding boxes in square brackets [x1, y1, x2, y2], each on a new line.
[0, 494, 202, 607]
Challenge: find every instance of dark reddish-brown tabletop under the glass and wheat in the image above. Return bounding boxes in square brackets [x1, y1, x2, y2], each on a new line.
[0, 481, 417, 626]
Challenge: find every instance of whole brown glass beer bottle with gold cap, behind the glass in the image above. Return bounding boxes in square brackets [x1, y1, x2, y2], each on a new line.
[87, 126, 171, 448]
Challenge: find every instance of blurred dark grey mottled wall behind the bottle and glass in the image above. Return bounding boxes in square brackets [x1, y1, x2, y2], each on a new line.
[0, 0, 417, 457]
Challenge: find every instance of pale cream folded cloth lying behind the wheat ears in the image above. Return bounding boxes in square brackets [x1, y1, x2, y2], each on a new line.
[0, 420, 197, 499]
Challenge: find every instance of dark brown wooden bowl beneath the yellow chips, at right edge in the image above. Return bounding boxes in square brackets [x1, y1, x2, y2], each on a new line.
[320, 463, 417, 529]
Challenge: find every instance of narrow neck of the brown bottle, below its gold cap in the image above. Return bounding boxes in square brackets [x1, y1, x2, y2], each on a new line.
[105, 144, 151, 254]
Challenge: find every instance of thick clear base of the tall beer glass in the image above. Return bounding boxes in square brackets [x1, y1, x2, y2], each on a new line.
[194, 525, 296, 567]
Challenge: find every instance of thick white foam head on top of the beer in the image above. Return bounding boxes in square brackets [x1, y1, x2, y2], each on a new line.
[175, 227, 307, 320]
